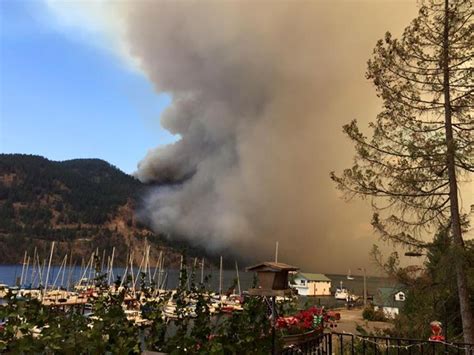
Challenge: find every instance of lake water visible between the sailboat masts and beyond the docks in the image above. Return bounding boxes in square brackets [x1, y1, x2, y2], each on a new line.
[0, 265, 391, 299]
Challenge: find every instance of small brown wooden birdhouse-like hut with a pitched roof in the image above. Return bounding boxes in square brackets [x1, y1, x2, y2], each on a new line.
[247, 261, 299, 296]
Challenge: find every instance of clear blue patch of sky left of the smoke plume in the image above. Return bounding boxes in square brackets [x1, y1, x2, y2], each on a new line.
[0, 0, 175, 173]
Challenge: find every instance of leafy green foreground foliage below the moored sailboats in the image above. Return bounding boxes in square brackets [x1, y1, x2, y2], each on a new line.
[0, 258, 278, 355]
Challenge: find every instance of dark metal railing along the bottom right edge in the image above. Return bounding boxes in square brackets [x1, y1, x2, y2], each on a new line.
[280, 333, 474, 355]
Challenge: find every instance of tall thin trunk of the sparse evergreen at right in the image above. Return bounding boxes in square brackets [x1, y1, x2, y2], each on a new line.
[442, 0, 474, 344]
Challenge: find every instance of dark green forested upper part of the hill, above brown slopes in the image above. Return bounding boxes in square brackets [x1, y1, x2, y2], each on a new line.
[0, 154, 142, 224]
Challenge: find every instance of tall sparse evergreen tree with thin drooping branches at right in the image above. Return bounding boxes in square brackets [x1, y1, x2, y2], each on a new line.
[331, 0, 474, 343]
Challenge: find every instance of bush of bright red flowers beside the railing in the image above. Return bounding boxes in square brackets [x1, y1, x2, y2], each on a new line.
[276, 306, 341, 334]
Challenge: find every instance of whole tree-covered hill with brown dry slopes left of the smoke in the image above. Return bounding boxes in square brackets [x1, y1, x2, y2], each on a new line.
[0, 154, 197, 264]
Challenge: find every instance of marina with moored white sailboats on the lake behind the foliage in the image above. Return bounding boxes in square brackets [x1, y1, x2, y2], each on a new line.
[0, 253, 392, 310]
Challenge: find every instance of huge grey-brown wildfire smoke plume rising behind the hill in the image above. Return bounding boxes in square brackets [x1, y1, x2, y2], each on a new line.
[126, 0, 416, 272]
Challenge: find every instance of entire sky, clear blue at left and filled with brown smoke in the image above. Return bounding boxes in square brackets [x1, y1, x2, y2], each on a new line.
[0, 0, 474, 272]
